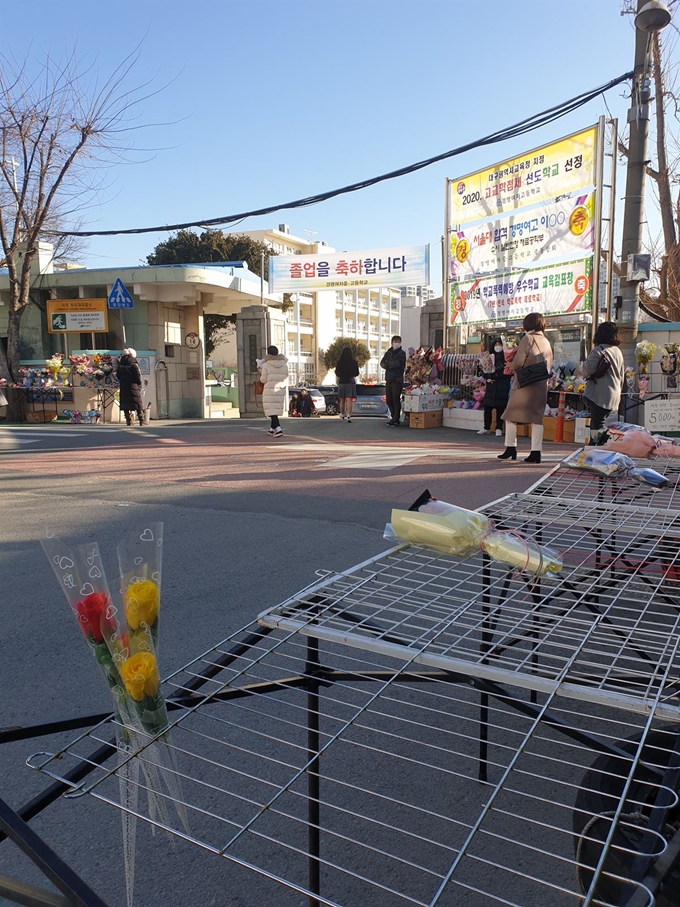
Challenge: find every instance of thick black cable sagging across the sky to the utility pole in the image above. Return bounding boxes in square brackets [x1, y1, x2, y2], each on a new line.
[45, 71, 634, 236]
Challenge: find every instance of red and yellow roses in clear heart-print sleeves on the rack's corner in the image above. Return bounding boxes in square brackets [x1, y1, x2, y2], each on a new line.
[42, 523, 188, 907]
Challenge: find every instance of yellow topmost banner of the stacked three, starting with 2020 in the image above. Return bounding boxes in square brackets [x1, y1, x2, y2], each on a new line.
[449, 126, 597, 228]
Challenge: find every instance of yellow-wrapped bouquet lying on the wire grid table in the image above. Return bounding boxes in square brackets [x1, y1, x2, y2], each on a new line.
[385, 491, 562, 576]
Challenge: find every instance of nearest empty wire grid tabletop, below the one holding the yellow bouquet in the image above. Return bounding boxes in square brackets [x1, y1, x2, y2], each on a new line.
[29, 626, 677, 907]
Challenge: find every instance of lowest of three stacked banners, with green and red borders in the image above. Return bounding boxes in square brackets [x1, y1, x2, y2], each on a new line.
[449, 258, 593, 324]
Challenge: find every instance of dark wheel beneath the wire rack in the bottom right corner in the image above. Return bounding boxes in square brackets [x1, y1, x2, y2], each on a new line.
[573, 727, 680, 907]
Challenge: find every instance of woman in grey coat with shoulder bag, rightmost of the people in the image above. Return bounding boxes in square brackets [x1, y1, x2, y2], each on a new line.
[581, 321, 625, 444]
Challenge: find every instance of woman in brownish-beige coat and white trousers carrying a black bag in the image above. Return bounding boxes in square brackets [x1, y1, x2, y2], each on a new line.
[498, 312, 552, 463]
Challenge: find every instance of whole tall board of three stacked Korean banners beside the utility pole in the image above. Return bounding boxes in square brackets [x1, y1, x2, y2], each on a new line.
[446, 126, 600, 325]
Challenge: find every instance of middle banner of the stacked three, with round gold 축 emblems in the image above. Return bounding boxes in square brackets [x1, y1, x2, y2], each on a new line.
[449, 192, 595, 281]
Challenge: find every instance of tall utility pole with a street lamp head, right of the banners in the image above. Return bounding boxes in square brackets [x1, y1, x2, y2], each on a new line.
[619, 0, 671, 376]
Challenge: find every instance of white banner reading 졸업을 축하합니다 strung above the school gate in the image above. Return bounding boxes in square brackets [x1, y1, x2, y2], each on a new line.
[269, 246, 430, 293]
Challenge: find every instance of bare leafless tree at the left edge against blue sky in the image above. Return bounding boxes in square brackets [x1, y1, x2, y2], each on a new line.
[0, 47, 162, 381]
